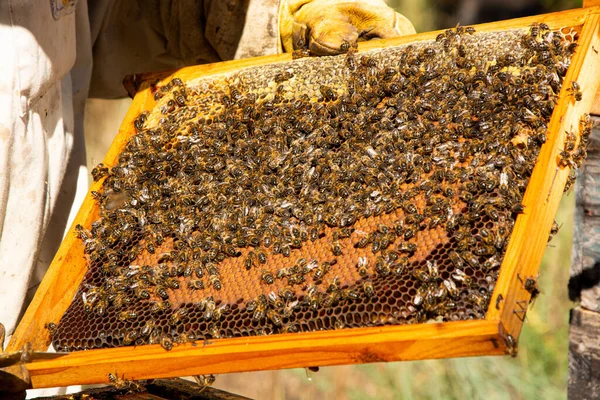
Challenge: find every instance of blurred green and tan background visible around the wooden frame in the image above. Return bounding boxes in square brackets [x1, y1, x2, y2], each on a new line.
[86, 0, 581, 400]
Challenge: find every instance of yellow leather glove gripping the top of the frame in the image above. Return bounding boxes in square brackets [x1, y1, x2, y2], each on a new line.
[279, 0, 416, 55]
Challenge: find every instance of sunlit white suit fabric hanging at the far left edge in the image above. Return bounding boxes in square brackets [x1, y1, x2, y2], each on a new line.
[0, 1, 91, 346]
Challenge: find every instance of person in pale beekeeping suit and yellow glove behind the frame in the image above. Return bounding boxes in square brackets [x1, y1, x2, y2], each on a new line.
[0, 0, 414, 378]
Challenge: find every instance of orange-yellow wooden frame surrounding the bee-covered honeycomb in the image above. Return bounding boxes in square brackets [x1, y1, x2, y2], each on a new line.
[8, 7, 600, 388]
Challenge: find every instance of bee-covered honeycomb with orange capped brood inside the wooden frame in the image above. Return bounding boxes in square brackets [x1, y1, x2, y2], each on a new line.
[51, 24, 576, 351]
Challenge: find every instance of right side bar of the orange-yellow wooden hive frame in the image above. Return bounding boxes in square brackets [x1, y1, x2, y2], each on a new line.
[486, 8, 600, 339]
